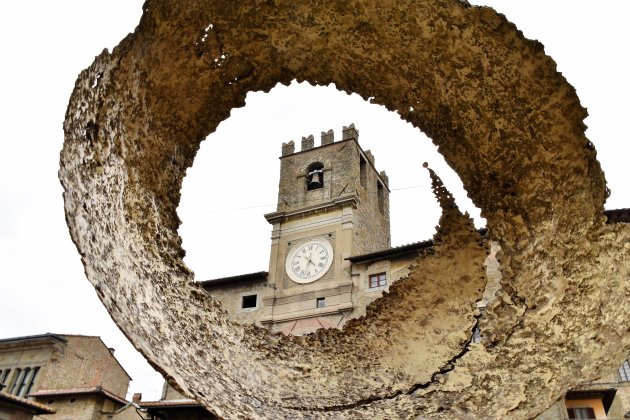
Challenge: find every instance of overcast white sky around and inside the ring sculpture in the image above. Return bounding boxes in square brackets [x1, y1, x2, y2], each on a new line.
[0, 0, 630, 400]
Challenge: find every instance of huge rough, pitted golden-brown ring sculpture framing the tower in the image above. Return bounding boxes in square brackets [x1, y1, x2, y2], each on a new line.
[59, 0, 630, 418]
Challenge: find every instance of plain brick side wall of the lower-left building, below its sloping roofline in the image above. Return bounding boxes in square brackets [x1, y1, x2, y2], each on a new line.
[39, 336, 130, 398]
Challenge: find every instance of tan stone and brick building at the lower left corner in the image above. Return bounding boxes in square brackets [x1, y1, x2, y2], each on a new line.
[0, 334, 142, 420]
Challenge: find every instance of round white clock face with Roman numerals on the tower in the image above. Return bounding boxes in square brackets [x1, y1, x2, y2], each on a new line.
[285, 239, 333, 284]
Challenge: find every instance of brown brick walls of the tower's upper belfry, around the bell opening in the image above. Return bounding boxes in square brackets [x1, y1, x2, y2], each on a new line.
[277, 140, 391, 255]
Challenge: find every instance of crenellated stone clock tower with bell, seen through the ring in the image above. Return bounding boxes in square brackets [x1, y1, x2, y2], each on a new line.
[260, 124, 390, 332]
